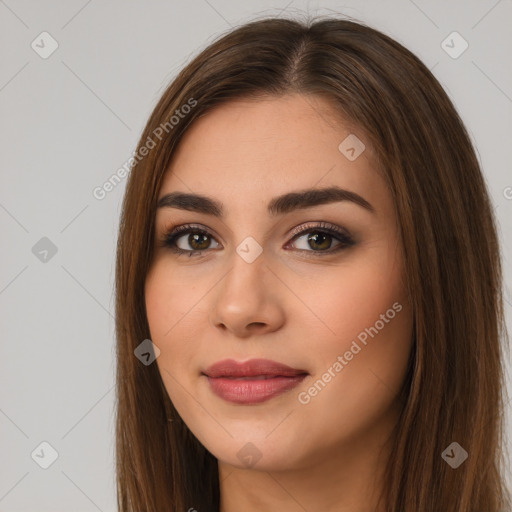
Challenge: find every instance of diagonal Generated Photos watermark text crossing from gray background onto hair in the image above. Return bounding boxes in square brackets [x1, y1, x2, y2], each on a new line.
[92, 98, 197, 201]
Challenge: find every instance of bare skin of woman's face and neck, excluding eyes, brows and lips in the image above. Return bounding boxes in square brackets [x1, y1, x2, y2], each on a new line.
[145, 94, 412, 512]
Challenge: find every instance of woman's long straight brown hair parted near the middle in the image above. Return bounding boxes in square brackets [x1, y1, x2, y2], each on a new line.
[116, 14, 510, 512]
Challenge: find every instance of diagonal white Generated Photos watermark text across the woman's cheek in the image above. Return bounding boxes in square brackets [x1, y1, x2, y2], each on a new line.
[297, 302, 402, 405]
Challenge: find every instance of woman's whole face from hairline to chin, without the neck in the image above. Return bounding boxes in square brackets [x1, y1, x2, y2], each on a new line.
[145, 95, 412, 470]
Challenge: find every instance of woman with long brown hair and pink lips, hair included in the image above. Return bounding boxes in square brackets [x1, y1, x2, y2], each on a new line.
[116, 14, 510, 512]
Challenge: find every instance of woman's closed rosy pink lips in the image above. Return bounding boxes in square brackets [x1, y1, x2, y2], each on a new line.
[203, 359, 308, 405]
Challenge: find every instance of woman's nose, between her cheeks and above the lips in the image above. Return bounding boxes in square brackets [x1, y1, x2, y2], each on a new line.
[210, 252, 285, 338]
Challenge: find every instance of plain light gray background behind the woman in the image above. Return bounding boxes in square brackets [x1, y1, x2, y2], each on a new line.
[0, 0, 512, 512]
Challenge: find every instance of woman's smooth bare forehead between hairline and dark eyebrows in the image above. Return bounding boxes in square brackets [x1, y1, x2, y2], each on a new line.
[159, 94, 384, 210]
